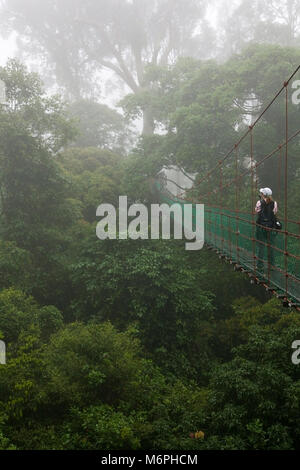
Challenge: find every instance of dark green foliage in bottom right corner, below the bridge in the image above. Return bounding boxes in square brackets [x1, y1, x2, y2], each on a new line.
[206, 302, 300, 450]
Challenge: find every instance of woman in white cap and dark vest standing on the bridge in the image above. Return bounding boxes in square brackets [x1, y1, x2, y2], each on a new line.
[255, 188, 278, 271]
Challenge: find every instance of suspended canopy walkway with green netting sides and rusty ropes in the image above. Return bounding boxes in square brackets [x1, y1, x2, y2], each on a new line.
[157, 66, 300, 311]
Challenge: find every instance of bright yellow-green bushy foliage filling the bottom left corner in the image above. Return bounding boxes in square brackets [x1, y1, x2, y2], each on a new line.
[0, 323, 207, 450]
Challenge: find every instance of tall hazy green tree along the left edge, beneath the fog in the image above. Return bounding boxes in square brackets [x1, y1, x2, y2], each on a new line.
[0, 61, 80, 303]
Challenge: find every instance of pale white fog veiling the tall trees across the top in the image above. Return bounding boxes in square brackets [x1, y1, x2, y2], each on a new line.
[0, 0, 300, 126]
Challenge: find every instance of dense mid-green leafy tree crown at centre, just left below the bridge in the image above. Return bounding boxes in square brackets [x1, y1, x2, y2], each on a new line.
[73, 239, 214, 382]
